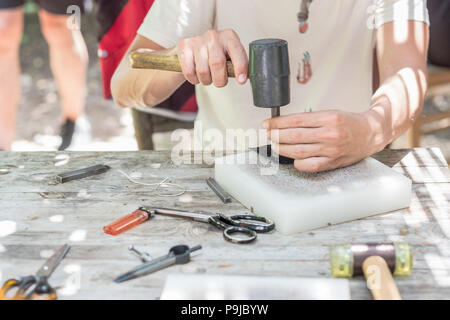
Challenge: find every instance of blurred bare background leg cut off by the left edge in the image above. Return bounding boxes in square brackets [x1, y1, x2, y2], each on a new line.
[0, 5, 23, 150]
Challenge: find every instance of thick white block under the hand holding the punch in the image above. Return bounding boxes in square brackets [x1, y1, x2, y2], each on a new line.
[215, 151, 411, 234]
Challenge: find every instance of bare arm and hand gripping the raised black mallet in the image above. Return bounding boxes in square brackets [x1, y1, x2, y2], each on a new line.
[111, 29, 248, 107]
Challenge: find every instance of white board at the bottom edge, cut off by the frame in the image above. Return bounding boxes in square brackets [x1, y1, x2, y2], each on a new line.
[161, 274, 350, 300]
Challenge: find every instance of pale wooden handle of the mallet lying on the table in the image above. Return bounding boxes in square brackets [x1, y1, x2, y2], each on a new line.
[362, 256, 402, 300]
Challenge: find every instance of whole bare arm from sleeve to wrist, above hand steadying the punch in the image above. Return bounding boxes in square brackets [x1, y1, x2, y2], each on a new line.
[366, 20, 428, 152]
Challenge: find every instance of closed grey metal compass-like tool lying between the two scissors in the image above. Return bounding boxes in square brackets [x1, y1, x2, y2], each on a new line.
[114, 245, 202, 283]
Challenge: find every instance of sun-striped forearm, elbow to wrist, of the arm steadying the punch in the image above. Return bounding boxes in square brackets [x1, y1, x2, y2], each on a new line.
[367, 67, 427, 152]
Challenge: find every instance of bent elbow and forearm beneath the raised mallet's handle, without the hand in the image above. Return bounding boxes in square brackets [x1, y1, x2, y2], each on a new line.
[111, 47, 186, 107]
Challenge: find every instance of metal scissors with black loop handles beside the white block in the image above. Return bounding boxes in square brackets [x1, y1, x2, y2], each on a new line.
[140, 207, 275, 244]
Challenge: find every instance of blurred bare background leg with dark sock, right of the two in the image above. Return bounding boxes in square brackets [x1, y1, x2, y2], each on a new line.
[39, 4, 88, 150]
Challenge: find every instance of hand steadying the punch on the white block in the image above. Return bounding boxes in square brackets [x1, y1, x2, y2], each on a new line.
[262, 110, 385, 172]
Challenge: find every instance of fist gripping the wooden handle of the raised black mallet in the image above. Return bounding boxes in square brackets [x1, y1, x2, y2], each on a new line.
[177, 30, 248, 88]
